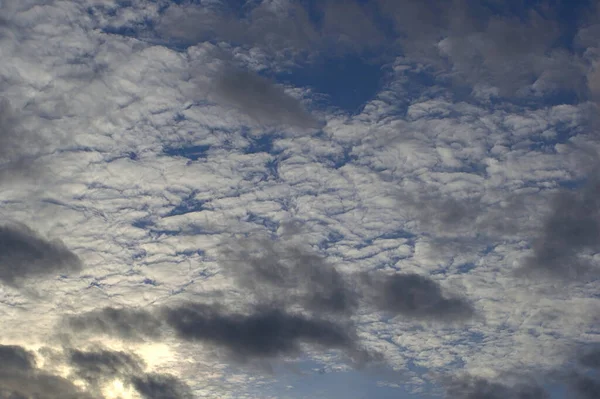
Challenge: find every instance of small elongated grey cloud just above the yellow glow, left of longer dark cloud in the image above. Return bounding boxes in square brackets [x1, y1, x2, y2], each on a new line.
[65, 307, 162, 340]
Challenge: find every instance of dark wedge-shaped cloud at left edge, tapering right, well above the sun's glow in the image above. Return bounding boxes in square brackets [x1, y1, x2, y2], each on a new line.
[0, 224, 81, 286]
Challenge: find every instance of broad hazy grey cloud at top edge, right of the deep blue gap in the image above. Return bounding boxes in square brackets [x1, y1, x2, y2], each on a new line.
[379, 0, 587, 96]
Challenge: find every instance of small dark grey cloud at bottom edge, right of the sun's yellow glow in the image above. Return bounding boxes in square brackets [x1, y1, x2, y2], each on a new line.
[131, 374, 193, 399]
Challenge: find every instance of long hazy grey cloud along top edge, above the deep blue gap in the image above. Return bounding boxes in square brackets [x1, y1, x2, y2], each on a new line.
[157, 0, 384, 57]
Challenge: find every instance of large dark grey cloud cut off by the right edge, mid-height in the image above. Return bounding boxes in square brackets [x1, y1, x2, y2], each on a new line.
[520, 178, 600, 278]
